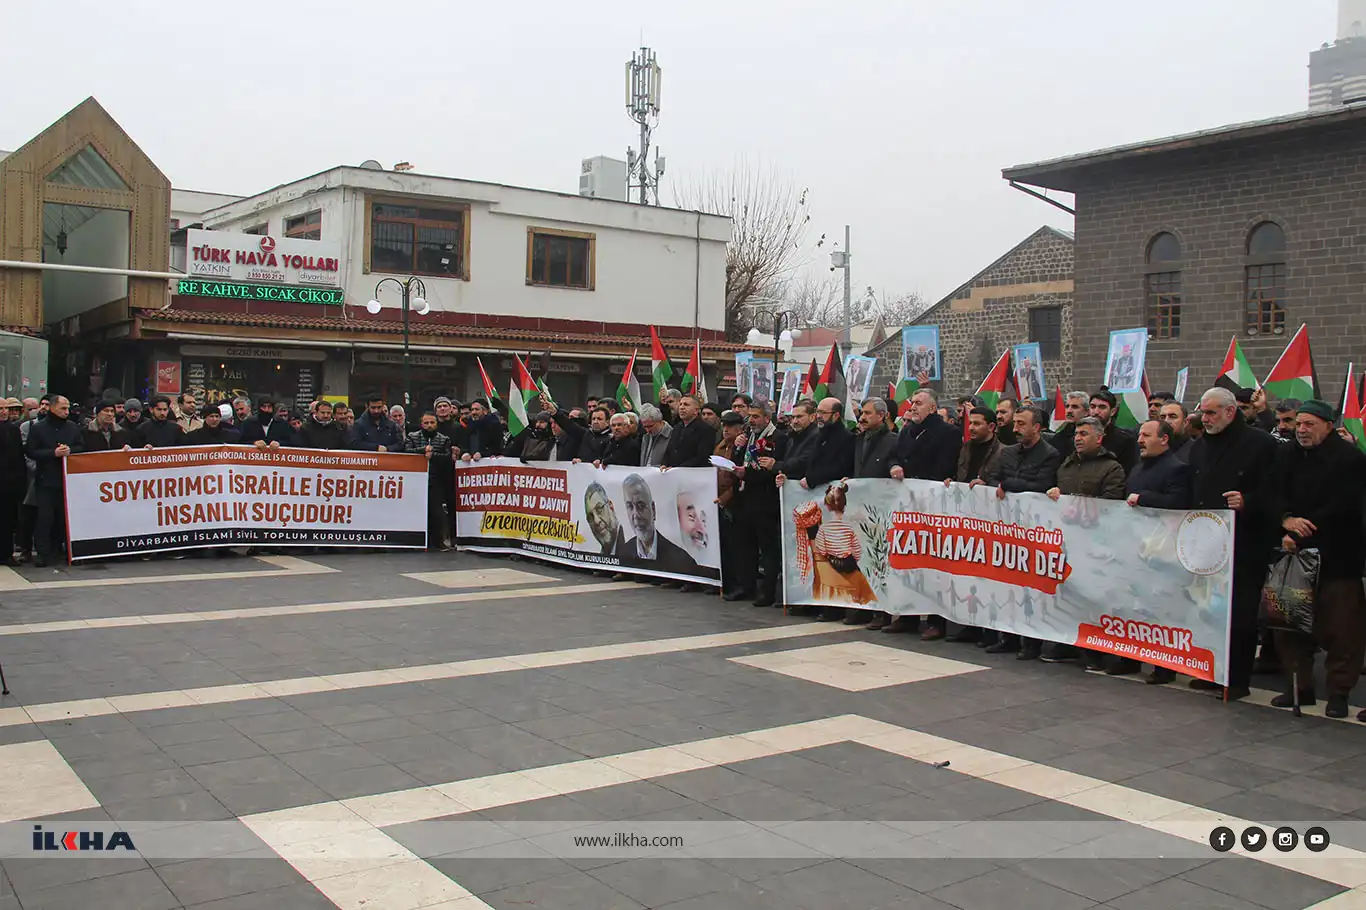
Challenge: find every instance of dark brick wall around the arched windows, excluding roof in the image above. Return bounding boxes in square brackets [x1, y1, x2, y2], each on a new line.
[1074, 119, 1366, 402]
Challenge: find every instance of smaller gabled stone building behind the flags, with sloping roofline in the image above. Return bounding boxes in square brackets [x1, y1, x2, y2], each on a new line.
[867, 225, 1072, 395]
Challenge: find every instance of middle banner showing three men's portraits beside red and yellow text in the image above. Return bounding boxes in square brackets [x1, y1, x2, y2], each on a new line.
[455, 458, 721, 585]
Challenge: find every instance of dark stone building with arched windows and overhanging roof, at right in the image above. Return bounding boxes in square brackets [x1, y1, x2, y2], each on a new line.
[1003, 102, 1366, 403]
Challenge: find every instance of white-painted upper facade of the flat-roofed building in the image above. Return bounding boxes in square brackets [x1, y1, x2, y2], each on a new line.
[182, 167, 731, 331]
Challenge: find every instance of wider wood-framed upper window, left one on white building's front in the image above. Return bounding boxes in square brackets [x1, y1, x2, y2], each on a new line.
[370, 202, 469, 279]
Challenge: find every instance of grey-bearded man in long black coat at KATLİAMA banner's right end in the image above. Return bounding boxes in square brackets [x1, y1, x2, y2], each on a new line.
[1188, 388, 1278, 701]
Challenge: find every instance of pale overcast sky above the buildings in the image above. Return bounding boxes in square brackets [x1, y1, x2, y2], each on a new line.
[0, 0, 1336, 299]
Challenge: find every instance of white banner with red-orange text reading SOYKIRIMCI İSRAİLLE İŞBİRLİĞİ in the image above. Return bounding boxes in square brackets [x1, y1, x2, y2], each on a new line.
[66, 445, 428, 562]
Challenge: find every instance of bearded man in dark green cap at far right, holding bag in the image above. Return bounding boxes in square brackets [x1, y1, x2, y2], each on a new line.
[1272, 399, 1366, 720]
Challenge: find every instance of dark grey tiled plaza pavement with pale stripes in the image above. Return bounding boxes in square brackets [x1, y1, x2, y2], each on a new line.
[0, 553, 1366, 910]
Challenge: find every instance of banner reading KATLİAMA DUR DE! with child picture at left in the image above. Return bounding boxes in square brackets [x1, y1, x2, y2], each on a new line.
[781, 480, 1233, 683]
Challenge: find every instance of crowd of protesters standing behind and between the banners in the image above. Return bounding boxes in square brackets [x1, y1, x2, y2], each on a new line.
[0, 374, 1366, 720]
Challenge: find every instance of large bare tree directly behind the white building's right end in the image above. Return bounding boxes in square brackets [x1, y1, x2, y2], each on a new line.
[673, 161, 808, 342]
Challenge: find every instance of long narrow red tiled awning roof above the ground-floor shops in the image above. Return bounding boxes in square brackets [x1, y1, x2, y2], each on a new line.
[141, 307, 753, 359]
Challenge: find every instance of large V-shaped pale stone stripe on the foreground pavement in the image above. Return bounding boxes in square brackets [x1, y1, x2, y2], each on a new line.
[240, 715, 1366, 910]
